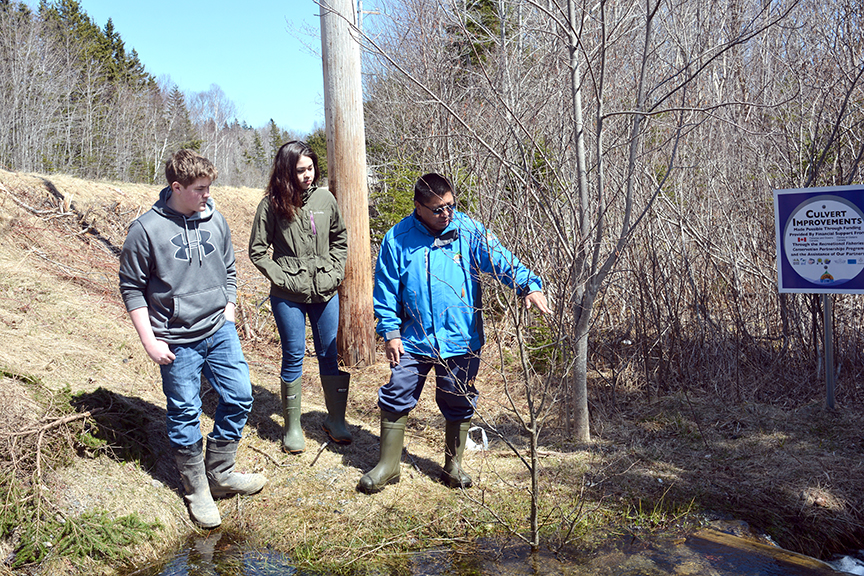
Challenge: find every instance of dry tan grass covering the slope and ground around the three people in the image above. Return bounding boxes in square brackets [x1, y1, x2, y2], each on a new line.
[0, 170, 864, 574]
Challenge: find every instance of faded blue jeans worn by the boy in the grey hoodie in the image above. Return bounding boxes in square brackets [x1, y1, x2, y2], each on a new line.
[160, 322, 252, 448]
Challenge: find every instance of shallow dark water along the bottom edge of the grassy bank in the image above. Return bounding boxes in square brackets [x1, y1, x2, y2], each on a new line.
[127, 529, 862, 576]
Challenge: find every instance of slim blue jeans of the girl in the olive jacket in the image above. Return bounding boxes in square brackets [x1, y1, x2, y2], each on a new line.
[270, 294, 339, 382]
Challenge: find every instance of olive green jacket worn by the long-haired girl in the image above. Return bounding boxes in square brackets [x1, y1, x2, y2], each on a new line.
[249, 188, 348, 303]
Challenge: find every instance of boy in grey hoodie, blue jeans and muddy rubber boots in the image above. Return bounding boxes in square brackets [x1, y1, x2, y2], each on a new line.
[120, 150, 267, 528]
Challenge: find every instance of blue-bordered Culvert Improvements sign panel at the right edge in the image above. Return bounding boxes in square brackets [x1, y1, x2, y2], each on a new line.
[774, 185, 864, 294]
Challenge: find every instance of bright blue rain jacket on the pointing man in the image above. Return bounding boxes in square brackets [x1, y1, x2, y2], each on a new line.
[373, 212, 543, 358]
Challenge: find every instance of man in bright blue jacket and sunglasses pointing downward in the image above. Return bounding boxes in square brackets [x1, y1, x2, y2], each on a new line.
[357, 173, 549, 494]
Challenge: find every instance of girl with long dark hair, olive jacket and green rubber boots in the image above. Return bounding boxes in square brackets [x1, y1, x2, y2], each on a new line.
[249, 141, 351, 454]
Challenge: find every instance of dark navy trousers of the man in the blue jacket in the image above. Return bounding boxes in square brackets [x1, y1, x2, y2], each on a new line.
[378, 352, 480, 421]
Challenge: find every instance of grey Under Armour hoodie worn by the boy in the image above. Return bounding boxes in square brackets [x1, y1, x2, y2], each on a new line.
[120, 187, 237, 344]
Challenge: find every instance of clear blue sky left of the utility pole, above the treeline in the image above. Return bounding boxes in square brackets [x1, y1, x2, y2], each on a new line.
[38, 0, 324, 135]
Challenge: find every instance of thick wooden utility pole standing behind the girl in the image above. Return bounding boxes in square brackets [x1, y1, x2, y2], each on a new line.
[319, 0, 375, 366]
